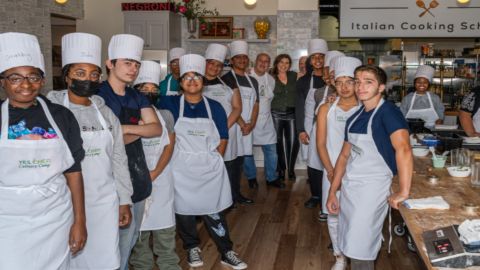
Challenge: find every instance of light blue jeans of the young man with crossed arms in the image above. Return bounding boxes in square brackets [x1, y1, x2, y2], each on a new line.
[119, 200, 145, 270]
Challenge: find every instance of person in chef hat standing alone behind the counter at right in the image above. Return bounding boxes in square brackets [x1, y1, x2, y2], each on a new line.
[400, 65, 445, 128]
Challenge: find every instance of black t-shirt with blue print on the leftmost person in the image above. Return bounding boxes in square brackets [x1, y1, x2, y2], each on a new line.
[0, 95, 85, 173]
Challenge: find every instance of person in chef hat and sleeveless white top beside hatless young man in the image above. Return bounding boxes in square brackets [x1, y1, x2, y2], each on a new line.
[314, 56, 362, 270]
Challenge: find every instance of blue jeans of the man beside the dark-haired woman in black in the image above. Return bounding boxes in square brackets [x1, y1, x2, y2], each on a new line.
[243, 143, 278, 182]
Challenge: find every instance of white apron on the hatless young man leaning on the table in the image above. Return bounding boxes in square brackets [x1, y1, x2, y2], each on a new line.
[338, 99, 393, 260]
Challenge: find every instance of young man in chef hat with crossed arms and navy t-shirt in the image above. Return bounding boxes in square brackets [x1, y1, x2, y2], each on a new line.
[98, 34, 162, 270]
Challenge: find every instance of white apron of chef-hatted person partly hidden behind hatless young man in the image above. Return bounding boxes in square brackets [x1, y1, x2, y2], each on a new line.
[322, 97, 358, 213]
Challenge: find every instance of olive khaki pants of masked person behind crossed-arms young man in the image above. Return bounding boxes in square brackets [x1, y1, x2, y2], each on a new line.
[130, 226, 181, 270]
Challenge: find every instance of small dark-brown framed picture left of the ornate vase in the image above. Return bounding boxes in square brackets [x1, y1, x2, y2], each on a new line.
[199, 17, 233, 38]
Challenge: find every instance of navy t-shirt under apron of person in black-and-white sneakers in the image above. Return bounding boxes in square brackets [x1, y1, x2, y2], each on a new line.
[158, 96, 228, 140]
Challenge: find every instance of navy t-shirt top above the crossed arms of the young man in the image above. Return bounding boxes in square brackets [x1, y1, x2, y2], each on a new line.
[97, 81, 150, 117]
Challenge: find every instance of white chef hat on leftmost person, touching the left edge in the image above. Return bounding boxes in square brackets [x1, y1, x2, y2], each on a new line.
[0, 32, 45, 73]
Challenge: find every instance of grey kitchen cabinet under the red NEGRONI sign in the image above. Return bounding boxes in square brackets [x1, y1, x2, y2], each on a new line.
[123, 11, 182, 50]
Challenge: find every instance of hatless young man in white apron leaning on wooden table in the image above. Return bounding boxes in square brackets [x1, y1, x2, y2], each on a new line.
[327, 65, 413, 270]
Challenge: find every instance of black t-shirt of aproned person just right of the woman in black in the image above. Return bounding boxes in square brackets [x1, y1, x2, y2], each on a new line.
[295, 74, 325, 133]
